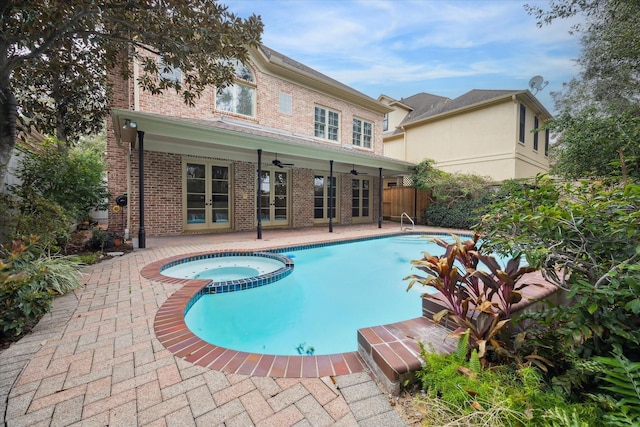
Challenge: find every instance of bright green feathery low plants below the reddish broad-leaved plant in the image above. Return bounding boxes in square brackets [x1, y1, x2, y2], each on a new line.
[416, 338, 600, 427]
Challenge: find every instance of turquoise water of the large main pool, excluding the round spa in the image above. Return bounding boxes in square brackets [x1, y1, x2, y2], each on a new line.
[185, 235, 452, 355]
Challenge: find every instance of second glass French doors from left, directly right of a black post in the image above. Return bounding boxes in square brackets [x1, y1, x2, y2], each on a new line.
[258, 170, 289, 226]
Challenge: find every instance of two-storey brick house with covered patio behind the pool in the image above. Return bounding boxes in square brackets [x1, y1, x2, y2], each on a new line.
[107, 46, 413, 243]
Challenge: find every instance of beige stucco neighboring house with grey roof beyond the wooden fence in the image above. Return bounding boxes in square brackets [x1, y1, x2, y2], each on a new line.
[378, 89, 551, 181]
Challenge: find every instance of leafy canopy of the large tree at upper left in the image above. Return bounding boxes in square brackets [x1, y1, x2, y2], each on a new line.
[0, 0, 263, 186]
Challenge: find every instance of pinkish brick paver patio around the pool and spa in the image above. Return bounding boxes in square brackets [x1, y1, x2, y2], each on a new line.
[0, 223, 458, 427]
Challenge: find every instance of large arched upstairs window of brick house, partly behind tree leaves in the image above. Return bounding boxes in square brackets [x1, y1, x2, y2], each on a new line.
[216, 60, 256, 117]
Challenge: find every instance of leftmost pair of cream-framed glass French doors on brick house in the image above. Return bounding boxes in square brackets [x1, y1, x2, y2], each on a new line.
[183, 162, 231, 231]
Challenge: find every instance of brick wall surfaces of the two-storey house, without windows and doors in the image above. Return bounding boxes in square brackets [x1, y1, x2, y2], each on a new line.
[107, 51, 383, 236]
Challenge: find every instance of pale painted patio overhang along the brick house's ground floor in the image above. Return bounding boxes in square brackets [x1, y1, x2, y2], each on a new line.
[111, 109, 415, 177]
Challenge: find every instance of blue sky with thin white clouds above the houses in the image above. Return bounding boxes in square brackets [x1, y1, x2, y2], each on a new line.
[221, 0, 580, 114]
